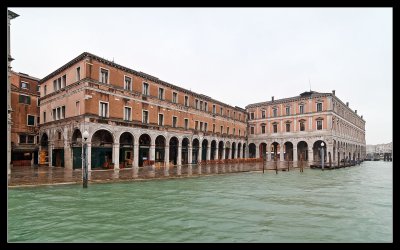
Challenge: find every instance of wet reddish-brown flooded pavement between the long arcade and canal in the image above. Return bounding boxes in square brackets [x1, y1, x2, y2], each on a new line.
[8, 162, 312, 187]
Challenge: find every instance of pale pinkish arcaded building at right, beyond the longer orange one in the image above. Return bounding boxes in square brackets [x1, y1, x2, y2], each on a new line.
[246, 91, 366, 163]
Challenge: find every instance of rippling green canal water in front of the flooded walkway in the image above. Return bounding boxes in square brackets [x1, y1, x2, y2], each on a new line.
[8, 162, 393, 242]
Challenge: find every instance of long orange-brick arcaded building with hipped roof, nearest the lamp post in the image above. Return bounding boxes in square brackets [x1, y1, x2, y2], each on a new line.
[40, 52, 247, 169]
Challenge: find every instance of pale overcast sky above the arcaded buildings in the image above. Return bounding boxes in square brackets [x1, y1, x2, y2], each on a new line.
[10, 8, 392, 144]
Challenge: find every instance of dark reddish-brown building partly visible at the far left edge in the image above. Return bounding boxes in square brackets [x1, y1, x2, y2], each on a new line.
[10, 71, 40, 166]
